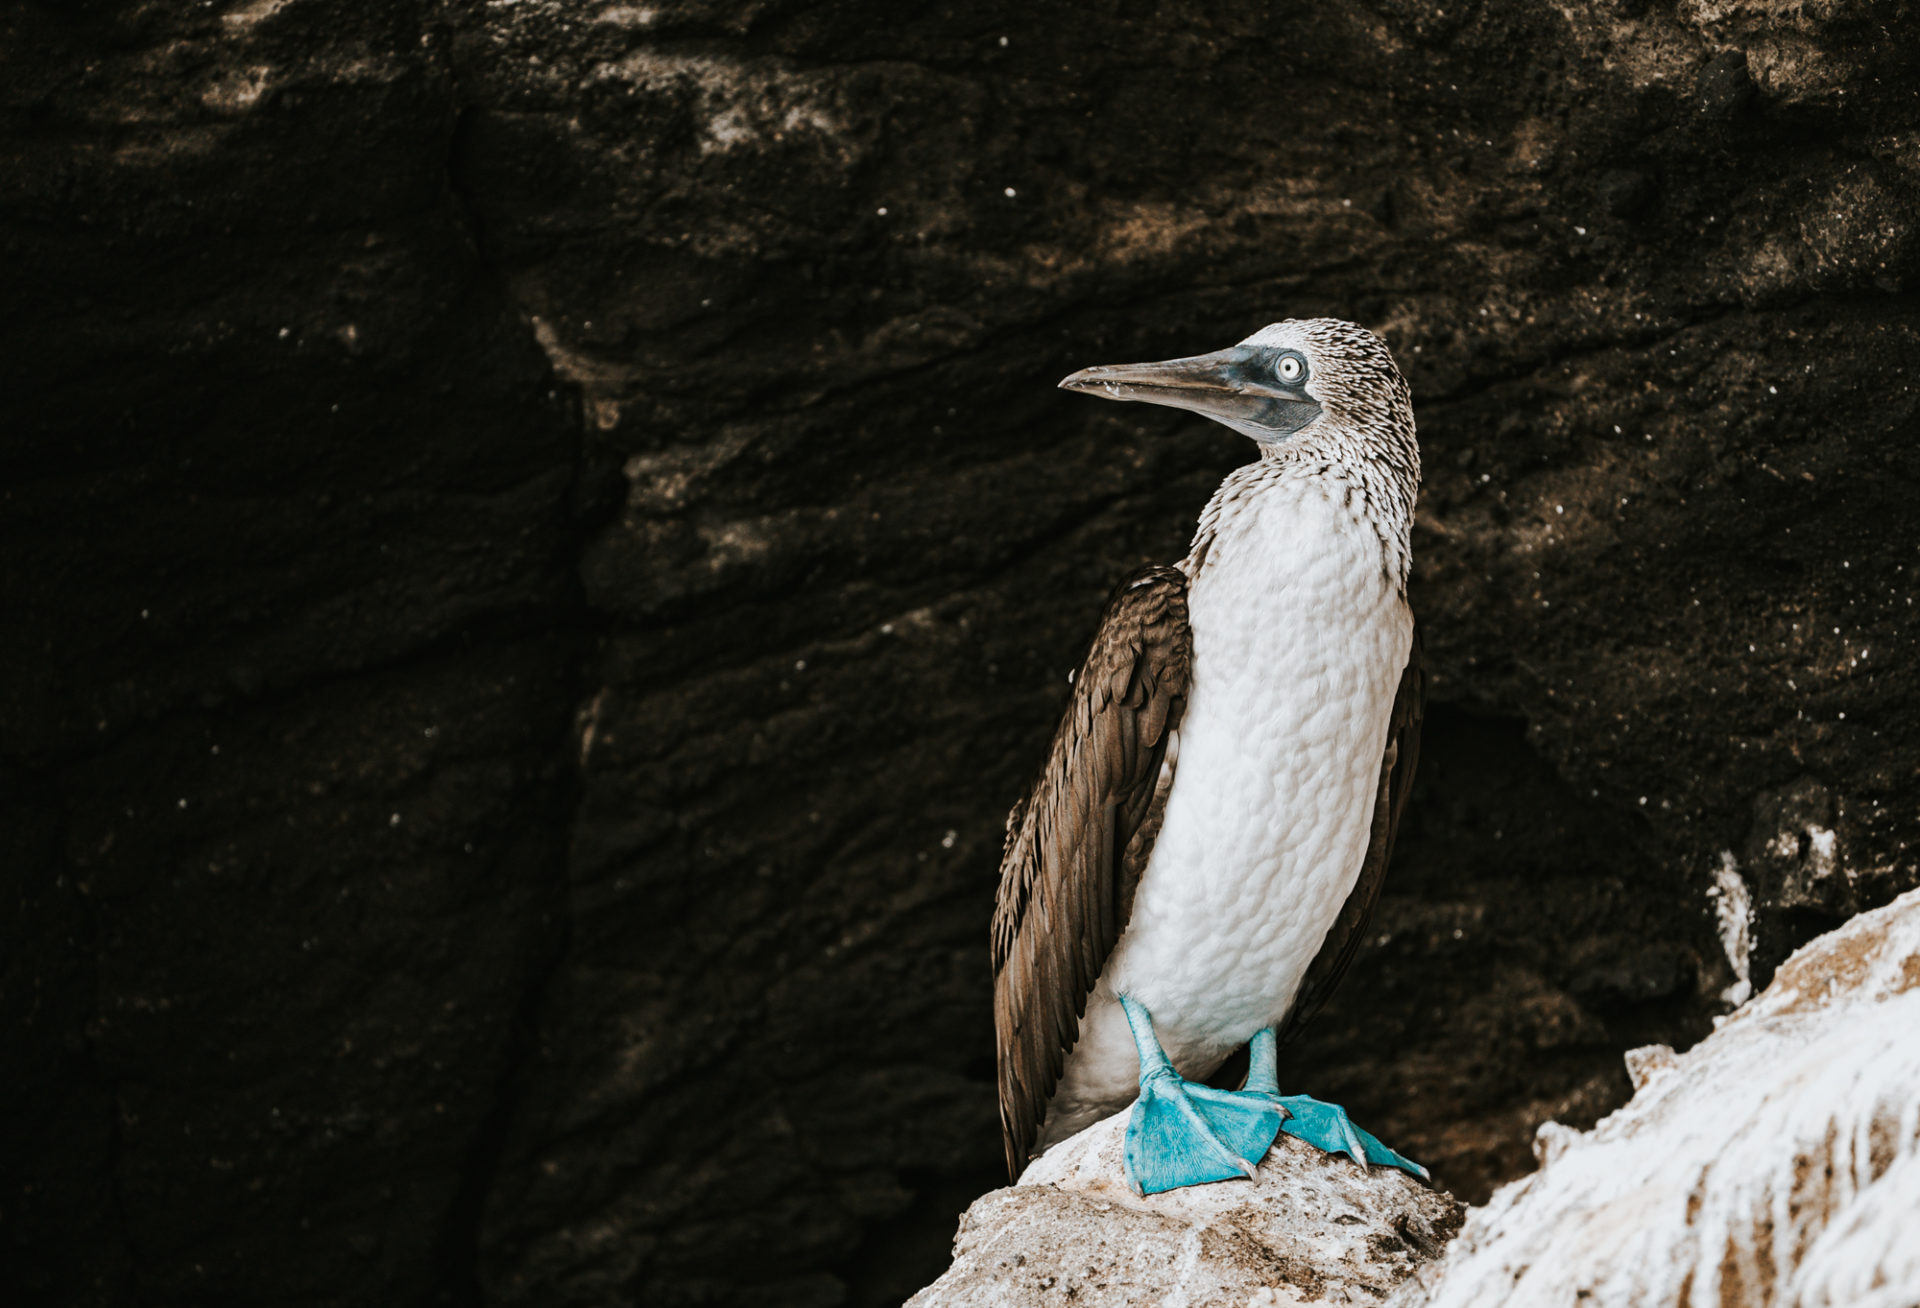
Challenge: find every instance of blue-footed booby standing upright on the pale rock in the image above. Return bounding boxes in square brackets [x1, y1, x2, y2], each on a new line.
[991, 319, 1427, 1195]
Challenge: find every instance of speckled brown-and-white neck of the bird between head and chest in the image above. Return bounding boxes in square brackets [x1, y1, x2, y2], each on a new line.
[1179, 442, 1419, 593]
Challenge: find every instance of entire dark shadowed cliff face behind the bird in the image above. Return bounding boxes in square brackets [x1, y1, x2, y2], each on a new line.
[11, 0, 1920, 1304]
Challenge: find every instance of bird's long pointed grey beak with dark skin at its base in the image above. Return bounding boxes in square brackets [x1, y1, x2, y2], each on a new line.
[1060, 346, 1321, 440]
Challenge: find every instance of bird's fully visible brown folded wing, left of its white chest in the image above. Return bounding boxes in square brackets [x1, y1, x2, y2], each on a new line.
[993, 569, 1192, 1175]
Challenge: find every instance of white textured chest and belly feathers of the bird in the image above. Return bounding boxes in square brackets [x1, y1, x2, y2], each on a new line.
[1102, 468, 1413, 1064]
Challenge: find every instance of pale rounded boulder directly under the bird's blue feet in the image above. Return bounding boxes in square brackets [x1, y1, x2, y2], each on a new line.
[908, 1112, 1461, 1308]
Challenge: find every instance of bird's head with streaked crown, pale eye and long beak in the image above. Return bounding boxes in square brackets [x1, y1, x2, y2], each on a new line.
[1060, 319, 1419, 460]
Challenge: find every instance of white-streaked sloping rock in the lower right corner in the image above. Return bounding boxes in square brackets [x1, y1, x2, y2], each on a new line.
[1396, 891, 1920, 1308]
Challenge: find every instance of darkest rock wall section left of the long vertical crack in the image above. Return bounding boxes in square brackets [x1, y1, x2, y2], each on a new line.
[0, 4, 586, 1304]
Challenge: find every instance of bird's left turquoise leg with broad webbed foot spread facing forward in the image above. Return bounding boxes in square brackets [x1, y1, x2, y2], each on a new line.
[1119, 995, 1284, 1195]
